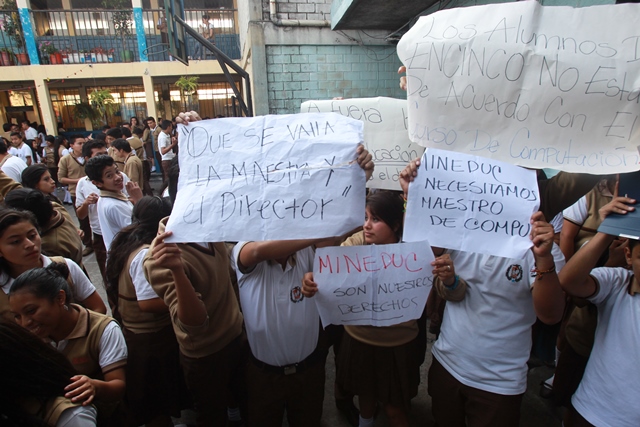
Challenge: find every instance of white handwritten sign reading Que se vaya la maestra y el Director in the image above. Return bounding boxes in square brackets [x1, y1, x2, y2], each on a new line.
[167, 113, 365, 242]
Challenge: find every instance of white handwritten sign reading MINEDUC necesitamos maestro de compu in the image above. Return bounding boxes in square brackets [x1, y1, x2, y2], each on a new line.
[403, 148, 540, 258]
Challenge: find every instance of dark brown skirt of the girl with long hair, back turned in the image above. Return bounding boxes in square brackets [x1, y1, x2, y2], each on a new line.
[123, 325, 191, 426]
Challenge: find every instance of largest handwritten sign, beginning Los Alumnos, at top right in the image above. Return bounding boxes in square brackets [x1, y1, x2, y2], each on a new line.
[398, 1, 640, 174]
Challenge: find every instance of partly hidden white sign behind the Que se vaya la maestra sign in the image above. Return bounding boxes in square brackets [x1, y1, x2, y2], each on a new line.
[300, 97, 424, 190]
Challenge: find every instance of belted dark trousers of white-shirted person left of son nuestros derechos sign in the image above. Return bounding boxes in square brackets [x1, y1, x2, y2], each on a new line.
[247, 353, 327, 427]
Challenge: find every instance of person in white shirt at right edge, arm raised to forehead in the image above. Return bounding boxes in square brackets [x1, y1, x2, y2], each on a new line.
[550, 197, 640, 427]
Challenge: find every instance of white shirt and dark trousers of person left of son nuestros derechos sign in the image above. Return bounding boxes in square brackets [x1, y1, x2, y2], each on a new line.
[232, 242, 327, 427]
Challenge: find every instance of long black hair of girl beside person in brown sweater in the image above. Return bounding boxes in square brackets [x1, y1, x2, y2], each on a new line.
[105, 196, 171, 305]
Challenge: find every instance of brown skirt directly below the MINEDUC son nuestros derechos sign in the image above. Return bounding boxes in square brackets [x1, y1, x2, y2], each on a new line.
[337, 332, 421, 406]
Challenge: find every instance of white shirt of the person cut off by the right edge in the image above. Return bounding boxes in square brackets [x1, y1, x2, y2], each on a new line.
[571, 267, 640, 427]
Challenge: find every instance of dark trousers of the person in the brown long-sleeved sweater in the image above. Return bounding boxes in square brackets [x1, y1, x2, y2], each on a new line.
[180, 334, 248, 427]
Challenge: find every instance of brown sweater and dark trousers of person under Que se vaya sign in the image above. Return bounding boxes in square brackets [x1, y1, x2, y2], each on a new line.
[144, 218, 245, 426]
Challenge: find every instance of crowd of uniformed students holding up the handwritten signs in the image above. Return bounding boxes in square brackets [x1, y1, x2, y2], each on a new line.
[0, 108, 640, 427]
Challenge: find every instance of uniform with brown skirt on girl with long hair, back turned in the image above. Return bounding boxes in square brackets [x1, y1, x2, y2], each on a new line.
[118, 245, 190, 425]
